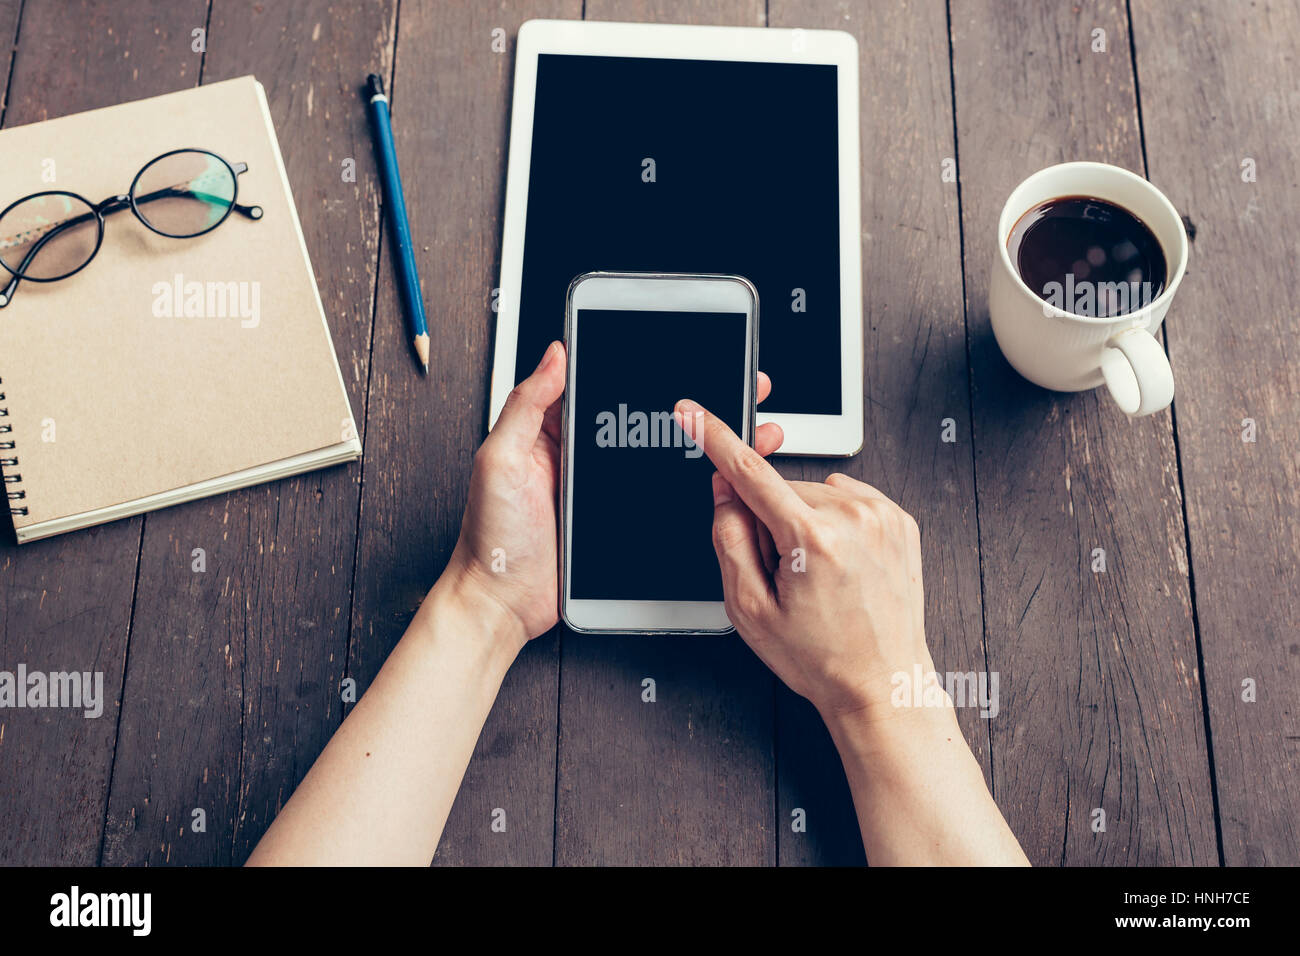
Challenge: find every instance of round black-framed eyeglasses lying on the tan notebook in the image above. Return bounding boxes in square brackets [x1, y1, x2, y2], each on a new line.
[0, 150, 261, 308]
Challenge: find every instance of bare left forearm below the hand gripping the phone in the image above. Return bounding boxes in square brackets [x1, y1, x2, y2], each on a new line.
[248, 581, 520, 866]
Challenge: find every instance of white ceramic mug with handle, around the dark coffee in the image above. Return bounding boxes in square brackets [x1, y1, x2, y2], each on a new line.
[988, 163, 1187, 418]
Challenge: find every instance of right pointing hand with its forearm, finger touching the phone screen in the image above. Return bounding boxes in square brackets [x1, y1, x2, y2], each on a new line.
[675, 401, 1028, 865]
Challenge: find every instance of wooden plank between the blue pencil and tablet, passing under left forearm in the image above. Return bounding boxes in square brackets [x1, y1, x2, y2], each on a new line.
[348, 0, 581, 865]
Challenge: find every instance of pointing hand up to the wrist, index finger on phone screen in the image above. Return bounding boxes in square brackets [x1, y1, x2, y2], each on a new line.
[675, 399, 933, 722]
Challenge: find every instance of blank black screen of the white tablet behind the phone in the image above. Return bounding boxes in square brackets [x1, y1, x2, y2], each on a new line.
[515, 53, 841, 415]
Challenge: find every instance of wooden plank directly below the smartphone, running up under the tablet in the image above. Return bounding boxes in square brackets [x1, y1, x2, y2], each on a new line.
[555, 0, 776, 866]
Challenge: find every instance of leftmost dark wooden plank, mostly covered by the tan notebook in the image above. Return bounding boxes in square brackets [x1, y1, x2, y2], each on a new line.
[0, 0, 207, 865]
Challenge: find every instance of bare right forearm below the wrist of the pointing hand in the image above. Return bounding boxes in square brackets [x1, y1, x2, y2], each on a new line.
[827, 706, 1028, 866]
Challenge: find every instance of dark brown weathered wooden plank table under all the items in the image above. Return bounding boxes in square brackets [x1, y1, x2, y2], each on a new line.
[0, 0, 1300, 865]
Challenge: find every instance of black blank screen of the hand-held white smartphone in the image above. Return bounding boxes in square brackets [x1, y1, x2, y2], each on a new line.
[569, 308, 746, 601]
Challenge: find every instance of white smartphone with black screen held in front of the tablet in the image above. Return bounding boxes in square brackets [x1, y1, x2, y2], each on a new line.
[560, 272, 758, 633]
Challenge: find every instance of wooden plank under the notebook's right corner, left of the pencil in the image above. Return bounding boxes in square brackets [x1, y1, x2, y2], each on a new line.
[104, 0, 395, 865]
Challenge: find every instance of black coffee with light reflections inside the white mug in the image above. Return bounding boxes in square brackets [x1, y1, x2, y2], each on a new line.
[1006, 196, 1167, 319]
